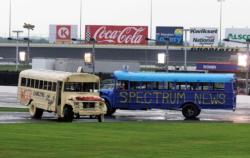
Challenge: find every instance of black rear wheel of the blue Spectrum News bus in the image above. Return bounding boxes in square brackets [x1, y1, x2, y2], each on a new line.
[182, 103, 200, 119]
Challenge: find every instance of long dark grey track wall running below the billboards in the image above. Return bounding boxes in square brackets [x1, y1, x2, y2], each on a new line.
[0, 46, 237, 65]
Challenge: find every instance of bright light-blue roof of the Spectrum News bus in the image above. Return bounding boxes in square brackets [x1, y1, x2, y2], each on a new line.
[114, 71, 235, 82]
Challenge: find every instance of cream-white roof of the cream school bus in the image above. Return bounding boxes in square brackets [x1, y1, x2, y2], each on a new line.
[20, 69, 99, 82]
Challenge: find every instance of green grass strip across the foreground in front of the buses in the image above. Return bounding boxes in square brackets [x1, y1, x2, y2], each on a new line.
[0, 122, 250, 158]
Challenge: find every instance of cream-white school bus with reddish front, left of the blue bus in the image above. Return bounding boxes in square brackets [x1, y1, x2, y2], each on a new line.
[18, 70, 107, 122]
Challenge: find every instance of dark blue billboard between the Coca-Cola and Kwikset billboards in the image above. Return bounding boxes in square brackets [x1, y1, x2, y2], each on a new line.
[156, 26, 183, 46]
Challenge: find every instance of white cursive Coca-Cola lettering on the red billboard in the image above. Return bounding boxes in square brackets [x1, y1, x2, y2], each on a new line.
[93, 26, 147, 44]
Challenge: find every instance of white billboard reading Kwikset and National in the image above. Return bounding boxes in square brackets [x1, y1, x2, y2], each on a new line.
[190, 28, 218, 46]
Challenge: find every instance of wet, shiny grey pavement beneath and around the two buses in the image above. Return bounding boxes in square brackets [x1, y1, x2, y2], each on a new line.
[0, 86, 250, 124]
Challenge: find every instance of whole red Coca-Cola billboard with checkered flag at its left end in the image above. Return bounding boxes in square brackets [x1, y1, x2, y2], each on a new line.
[85, 25, 148, 44]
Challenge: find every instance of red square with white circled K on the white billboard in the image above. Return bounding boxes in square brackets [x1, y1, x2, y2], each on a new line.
[56, 25, 71, 40]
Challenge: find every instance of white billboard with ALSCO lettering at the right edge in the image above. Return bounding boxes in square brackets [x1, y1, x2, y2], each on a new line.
[225, 28, 250, 47]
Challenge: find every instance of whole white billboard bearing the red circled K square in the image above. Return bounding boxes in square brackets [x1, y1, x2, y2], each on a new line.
[49, 25, 77, 43]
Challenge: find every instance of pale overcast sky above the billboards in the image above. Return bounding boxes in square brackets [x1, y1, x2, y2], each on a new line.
[0, 0, 250, 37]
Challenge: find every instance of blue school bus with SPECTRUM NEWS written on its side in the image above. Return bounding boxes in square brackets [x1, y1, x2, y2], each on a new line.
[100, 71, 237, 119]
